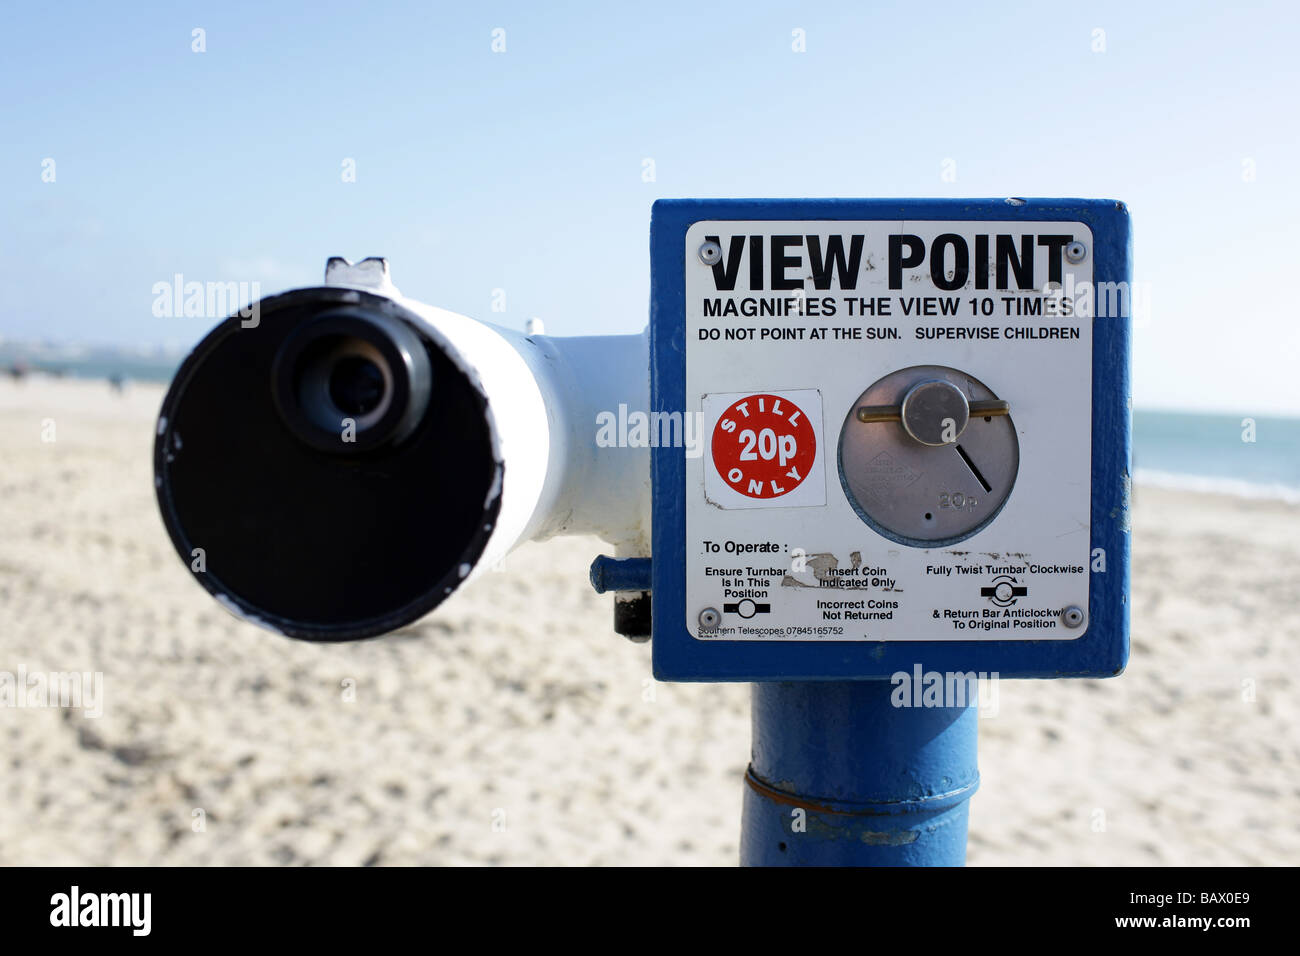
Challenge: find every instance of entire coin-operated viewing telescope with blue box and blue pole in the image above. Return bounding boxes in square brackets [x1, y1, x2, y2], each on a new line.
[156, 199, 1131, 865]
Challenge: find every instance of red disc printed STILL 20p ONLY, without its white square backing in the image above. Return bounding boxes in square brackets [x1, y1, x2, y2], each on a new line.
[711, 394, 816, 498]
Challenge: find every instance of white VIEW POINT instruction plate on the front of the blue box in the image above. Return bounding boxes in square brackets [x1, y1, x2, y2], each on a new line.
[683, 220, 1105, 641]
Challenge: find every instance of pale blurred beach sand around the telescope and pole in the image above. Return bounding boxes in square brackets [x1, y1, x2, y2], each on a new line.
[0, 380, 1300, 865]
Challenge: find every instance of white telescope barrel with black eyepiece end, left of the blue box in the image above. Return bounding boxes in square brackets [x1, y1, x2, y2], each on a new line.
[155, 258, 650, 641]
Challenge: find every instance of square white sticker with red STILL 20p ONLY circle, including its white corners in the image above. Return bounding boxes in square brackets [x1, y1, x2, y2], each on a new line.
[703, 389, 826, 509]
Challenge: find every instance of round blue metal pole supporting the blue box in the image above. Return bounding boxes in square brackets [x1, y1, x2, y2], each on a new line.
[740, 680, 979, 866]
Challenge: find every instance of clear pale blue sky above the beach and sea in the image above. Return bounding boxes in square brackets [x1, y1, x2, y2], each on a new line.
[0, 0, 1300, 414]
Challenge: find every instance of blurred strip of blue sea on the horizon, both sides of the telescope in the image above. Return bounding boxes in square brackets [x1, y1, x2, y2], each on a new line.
[0, 343, 1300, 503]
